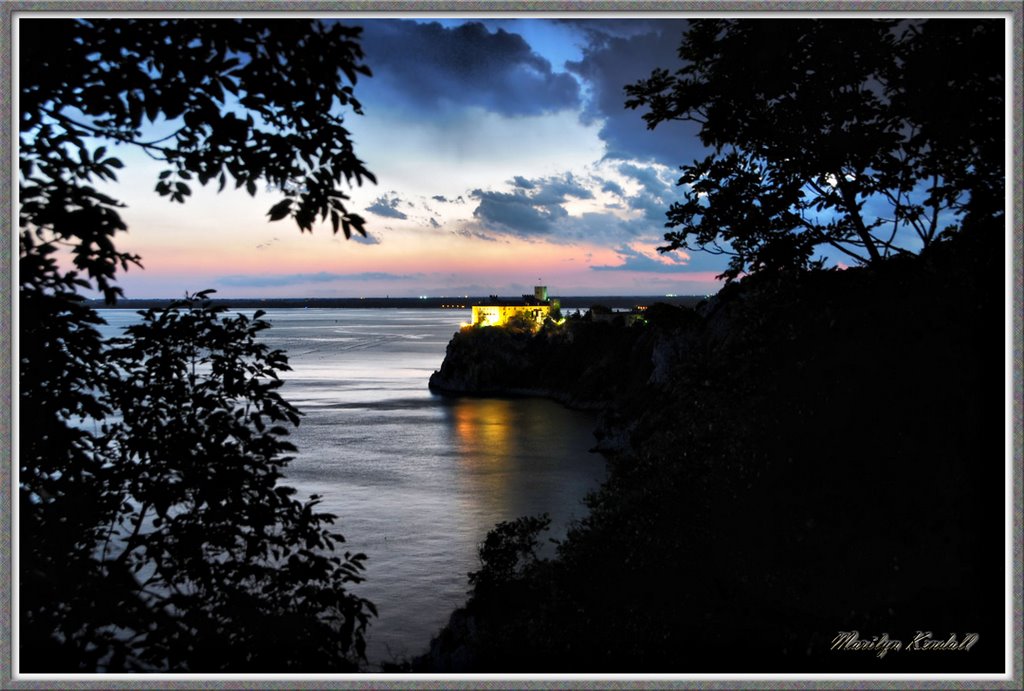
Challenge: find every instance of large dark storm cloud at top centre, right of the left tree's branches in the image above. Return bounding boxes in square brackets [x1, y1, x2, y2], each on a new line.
[359, 19, 580, 116]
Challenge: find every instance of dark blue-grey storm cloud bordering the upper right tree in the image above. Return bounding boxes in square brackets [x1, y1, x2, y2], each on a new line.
[565, 19, 703, 167]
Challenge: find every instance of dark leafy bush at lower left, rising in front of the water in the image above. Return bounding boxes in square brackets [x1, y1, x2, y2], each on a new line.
[22, 293, 375, 671]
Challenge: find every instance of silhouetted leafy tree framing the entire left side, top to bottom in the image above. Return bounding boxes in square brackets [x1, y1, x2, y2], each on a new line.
[18, 18, 374, 672]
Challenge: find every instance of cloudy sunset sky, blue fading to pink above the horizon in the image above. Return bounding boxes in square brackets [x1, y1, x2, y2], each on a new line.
[70, 16, 737, 298]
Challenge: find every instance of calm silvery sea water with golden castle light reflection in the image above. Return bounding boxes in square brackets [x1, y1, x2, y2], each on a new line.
[101, 309, 604, 664]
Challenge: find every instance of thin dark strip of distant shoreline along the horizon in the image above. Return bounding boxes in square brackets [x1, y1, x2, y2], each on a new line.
[87, 295, 705, 309]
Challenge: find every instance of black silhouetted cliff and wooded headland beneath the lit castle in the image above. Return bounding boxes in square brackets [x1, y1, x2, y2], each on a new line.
[414, 225, 1007, 673]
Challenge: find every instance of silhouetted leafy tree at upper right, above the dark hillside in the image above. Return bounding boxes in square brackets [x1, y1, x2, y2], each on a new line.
[626, 19, 1005, 280]
